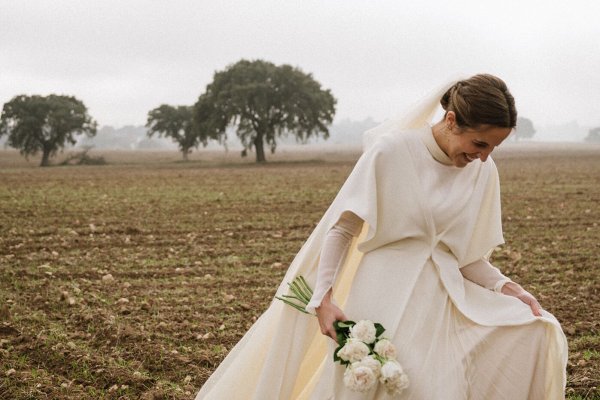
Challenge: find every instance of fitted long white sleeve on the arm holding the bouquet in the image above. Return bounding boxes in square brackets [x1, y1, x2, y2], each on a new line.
[306, 212, 363, 314]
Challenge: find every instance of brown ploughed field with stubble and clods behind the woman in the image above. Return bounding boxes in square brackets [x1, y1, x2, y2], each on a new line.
[0, 143, 600, 399]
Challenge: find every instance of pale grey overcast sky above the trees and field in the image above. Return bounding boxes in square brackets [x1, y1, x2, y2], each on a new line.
[0, 0, 600, 127]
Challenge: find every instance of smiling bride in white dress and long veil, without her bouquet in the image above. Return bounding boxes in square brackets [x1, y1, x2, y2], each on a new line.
[196, 74, 567, 400]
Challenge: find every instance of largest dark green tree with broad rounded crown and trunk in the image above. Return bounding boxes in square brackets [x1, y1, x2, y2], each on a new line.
[194, 60, 336, 162]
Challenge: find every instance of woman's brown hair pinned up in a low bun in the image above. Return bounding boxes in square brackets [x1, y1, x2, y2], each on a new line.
[440, 74, 517, 129]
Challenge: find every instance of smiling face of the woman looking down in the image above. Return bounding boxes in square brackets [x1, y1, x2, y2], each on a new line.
[443, 111, 512, 168]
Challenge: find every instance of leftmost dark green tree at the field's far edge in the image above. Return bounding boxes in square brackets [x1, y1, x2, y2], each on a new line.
[0, 94, 97, 166]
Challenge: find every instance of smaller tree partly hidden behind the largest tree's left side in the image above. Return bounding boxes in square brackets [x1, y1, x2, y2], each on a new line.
[146, 104, 199, 160]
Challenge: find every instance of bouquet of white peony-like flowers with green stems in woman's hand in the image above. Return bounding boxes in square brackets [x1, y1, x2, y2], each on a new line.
[275, 276, 409, 395]
